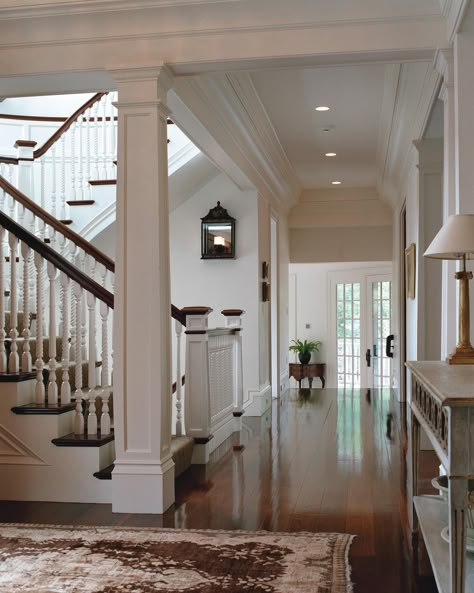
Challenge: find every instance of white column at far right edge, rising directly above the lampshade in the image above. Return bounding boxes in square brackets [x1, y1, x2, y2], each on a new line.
[454, 15, 474, 336]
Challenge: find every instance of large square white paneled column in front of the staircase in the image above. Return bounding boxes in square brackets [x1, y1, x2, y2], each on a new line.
[112, 66, 174, 513]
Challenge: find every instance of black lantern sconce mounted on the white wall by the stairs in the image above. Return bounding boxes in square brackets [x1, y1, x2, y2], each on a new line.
[201, 202, 235, 259]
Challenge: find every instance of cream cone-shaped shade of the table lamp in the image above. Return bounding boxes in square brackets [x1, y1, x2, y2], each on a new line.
[424, 214, 474, 259]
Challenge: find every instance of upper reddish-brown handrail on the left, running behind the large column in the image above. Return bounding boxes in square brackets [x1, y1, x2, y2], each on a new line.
[0, 175, 115, 272]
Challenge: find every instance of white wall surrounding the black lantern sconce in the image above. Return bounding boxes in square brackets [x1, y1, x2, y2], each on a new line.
[169, 175, 260, 408]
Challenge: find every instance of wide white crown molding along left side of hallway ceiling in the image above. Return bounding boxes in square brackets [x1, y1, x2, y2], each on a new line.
[173, 73, 301, 209]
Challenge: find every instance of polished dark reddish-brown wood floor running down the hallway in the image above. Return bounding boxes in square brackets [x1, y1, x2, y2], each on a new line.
[0, 389, 436, 593]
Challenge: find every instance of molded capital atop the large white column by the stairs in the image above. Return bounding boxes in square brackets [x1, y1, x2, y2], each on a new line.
[109, 64, 174, 105]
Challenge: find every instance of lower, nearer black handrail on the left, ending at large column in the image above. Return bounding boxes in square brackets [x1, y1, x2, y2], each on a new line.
[0, 212, 114, 309]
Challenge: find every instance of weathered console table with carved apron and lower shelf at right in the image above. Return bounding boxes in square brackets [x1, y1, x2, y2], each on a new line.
[407, 361, 474, 593]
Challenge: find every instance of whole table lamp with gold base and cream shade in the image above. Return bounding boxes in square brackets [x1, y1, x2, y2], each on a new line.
[424, 214, 474, 364]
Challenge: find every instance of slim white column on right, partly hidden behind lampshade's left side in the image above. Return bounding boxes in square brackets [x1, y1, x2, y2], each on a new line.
[435, 49, 458, 360]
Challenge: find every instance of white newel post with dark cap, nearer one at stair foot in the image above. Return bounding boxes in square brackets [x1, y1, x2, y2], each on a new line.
[181, 307, 213, 463]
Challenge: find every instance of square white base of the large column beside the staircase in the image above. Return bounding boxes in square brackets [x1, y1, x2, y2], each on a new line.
[112, 456, 174, 514]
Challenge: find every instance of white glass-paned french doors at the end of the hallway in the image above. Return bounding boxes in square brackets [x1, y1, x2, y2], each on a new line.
[329, 269, 392, 388]
